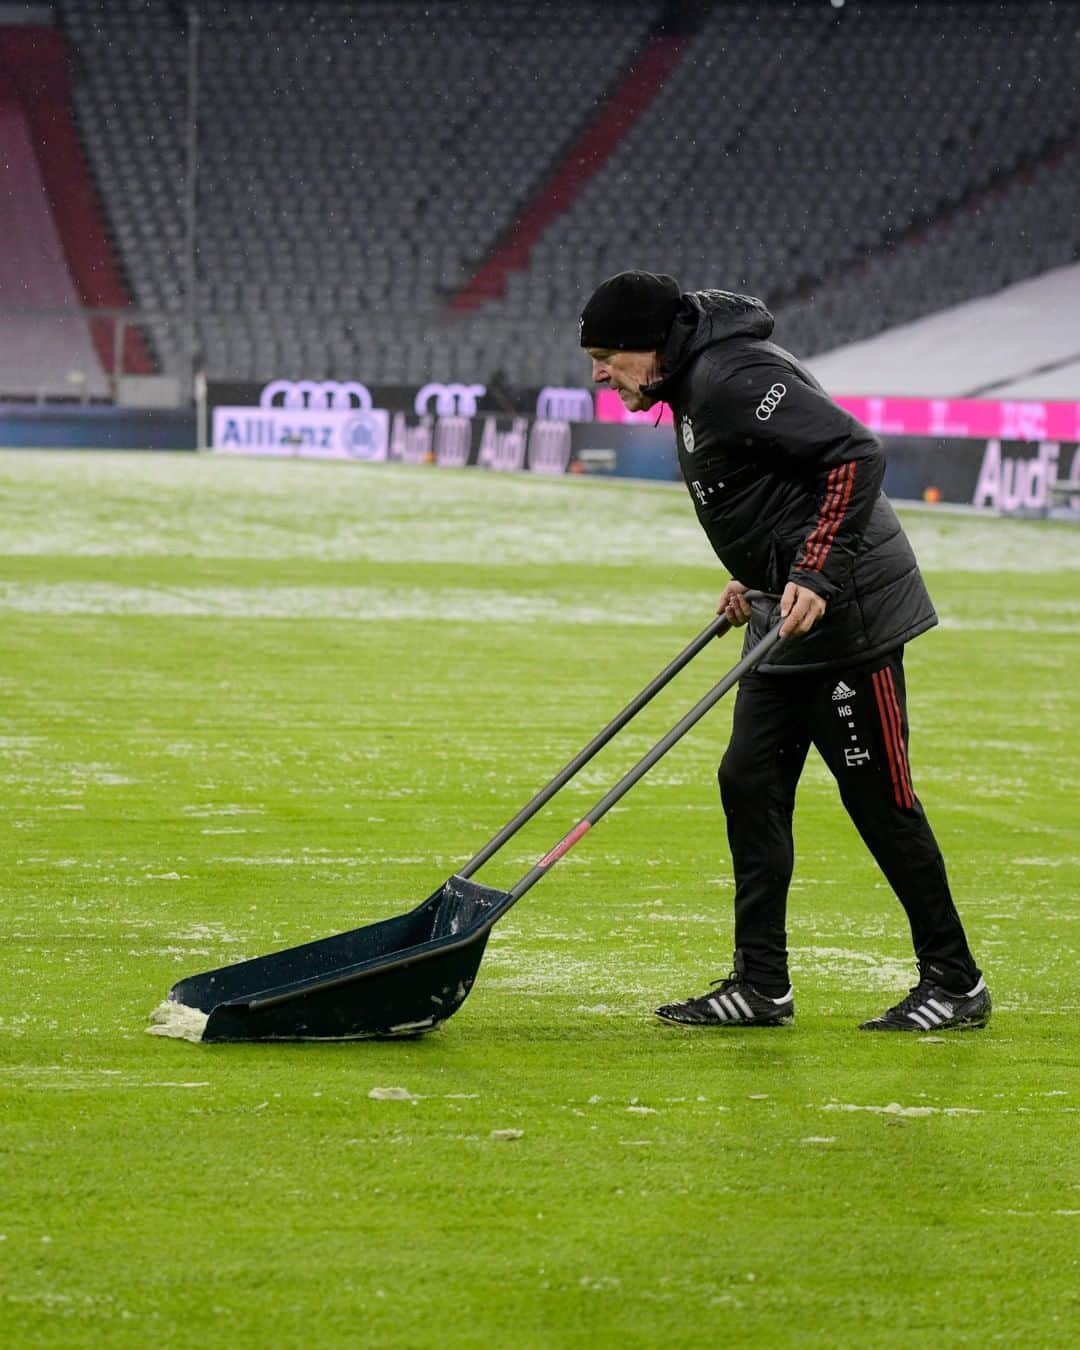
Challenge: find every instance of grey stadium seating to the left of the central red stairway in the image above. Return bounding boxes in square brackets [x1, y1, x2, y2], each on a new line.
[61, 0, 656, 378]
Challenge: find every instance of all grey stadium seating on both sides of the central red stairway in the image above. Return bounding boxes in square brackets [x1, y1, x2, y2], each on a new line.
[58, 0, 1080, 383]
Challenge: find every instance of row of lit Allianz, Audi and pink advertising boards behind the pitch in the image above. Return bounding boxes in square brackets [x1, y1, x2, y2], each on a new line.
[211, 379, 1080, 518]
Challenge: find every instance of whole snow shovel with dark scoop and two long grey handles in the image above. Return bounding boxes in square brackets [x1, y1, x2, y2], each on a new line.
[157, 604, 780, 1041]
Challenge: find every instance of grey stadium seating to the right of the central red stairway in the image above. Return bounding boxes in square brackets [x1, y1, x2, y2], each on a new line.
[501, 3, 1080, 364]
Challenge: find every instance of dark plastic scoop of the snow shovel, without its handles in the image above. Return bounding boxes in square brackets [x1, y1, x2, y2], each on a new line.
[169, 876, 512, 1041]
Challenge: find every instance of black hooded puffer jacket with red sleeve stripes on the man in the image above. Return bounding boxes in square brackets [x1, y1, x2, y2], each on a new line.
[645, 290, 937, 672]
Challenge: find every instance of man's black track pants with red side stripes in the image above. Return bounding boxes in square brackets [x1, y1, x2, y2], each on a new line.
[720, 648, 979, 994]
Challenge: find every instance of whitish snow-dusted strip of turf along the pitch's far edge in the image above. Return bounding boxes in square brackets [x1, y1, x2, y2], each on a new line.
[0, 452, 1080, 572]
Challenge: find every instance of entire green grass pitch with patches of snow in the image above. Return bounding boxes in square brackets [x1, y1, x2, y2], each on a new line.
[0, 452, 1080, 1347]
